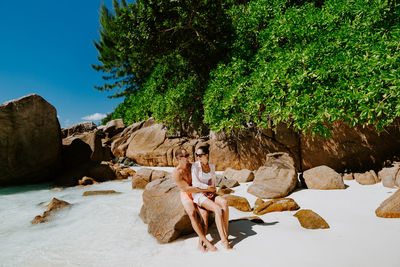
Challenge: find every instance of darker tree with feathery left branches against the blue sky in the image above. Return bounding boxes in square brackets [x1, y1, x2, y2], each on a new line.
[95, 0, 238, 133]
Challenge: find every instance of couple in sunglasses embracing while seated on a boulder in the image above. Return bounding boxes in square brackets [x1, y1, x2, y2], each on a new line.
[172, 146, 231, 251]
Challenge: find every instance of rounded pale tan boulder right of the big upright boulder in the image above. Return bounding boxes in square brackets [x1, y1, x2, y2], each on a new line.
[303, 165, 346, 190]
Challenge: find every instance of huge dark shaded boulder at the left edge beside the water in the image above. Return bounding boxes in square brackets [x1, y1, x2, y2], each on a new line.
[0, 94, 61, 186]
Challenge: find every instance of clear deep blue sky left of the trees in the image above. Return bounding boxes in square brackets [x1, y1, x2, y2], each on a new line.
[0, 0, 125, 127]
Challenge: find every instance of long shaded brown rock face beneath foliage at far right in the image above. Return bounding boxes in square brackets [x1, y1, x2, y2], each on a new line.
[300, 119, 400, 172]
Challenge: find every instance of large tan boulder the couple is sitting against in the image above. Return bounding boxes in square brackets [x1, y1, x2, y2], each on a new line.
[139, 178, 193, 243]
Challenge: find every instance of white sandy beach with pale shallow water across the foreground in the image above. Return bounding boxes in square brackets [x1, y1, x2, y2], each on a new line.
[0, 168, 400, 267]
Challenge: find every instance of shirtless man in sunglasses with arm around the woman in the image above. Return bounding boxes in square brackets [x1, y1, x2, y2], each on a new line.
[172, 148, 217, 251]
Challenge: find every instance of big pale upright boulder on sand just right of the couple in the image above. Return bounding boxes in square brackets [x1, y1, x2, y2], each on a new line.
[247, 152, 297, 198]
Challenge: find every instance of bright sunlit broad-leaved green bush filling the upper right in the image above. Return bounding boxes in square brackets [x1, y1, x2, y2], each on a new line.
[203, 0, 400, 135]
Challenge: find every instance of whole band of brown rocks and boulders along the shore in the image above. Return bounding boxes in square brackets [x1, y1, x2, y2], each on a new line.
[0, 95, 400, 243]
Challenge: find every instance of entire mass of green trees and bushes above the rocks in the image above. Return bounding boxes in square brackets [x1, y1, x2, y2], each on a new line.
[94, 0, 400, 135]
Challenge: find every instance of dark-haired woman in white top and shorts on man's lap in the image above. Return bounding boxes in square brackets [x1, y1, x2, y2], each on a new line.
[192, 146, 231, 249]
